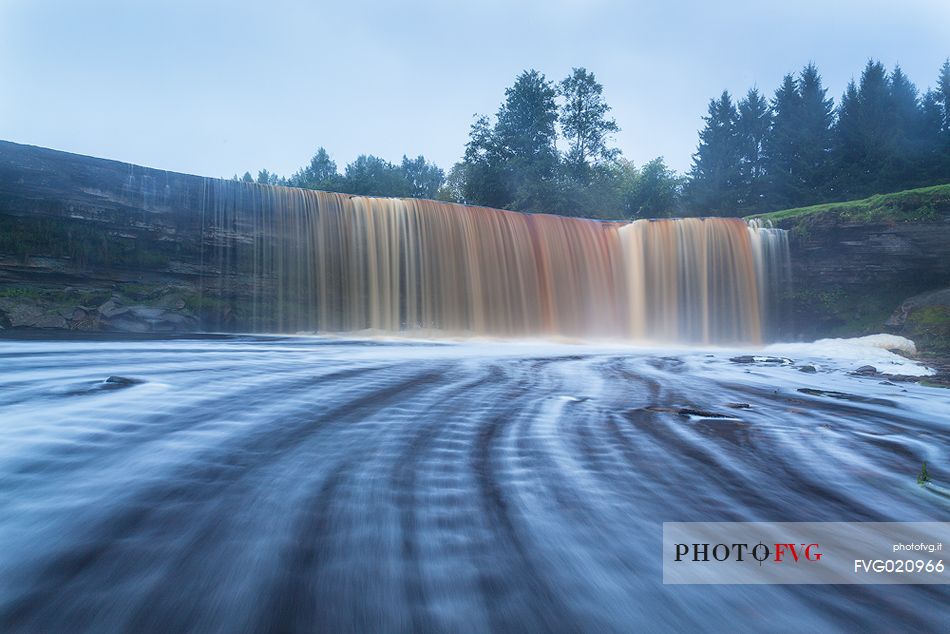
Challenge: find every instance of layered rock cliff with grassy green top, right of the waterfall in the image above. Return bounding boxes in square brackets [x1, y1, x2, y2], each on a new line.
[764, 186, 950, 348]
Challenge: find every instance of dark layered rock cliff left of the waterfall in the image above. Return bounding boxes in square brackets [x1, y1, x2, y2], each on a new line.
[0, 142, 256, 331]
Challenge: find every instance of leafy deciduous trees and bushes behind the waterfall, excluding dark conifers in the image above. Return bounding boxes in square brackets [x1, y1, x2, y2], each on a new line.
[235, 68, 682, 218]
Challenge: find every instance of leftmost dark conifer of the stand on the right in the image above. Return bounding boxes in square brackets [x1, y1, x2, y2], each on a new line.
[687, 91, 739, 216]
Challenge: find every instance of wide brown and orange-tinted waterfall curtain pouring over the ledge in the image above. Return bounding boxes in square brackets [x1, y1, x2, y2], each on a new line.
[201, 179, 788, 343]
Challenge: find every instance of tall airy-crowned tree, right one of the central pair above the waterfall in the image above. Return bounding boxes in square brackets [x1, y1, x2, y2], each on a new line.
[558, 68, 620, 181]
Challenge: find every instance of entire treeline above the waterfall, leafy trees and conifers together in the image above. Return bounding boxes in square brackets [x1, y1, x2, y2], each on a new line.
[235, 60, 950, 219]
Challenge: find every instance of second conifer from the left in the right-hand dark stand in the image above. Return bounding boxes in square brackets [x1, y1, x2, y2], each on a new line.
[736, 88, 772, 211]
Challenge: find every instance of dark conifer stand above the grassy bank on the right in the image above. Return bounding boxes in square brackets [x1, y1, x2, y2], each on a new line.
[683, 61, 950, 216]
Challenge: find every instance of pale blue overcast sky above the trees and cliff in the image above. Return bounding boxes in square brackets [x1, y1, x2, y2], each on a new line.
[0, 0, 950, 176]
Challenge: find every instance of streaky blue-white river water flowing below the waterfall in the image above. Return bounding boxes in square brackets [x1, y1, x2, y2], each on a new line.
[0, 334, 950, 632]
